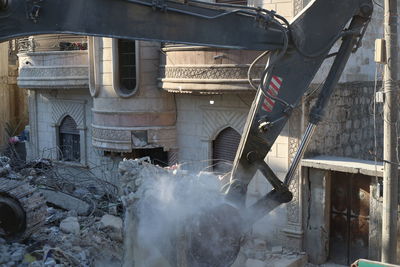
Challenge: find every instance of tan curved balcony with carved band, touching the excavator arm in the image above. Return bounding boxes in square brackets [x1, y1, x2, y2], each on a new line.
[159, 45, 265, 94]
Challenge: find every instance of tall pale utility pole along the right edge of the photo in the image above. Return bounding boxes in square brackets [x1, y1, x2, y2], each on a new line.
[382, 0, 399, 263]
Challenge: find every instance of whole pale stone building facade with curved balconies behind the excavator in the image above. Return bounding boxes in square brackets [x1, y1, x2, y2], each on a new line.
[14, 0, 390, 263]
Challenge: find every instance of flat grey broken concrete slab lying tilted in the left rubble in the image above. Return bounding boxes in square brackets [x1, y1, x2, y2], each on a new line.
[39, 188, 90, 215]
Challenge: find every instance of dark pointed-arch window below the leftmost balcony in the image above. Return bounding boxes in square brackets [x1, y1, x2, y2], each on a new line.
[59, 116, 81, 162]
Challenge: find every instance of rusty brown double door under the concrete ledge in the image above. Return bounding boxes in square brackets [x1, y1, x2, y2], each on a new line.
[329, 171, 371, 265]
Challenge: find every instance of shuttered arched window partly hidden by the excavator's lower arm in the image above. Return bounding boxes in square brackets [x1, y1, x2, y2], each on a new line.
[212, 127, 240, 173]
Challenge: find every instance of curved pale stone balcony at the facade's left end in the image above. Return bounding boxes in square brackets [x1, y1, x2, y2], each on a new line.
[17, 35, 89, 89]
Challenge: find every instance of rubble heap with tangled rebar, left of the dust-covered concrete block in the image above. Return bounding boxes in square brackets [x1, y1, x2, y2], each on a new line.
[0, 157, 123, 267]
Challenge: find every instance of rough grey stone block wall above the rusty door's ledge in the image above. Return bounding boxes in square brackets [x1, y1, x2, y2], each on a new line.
[305, 82, 383, 160]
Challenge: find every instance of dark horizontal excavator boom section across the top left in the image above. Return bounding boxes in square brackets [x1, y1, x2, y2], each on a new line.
[0, 0, 284, 50]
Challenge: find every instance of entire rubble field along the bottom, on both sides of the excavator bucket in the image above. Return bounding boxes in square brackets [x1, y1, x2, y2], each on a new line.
[0, 157, 306, 267]
